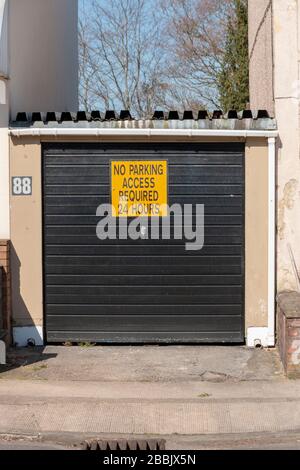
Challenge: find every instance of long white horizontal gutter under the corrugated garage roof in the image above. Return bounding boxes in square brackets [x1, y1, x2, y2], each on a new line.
[9, 127, 278, 139]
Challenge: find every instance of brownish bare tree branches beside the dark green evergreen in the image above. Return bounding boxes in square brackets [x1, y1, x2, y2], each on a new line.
[161, 0, 233, 107]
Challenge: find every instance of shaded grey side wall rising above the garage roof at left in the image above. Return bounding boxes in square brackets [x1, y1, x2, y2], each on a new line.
[8, 0, 78, 117]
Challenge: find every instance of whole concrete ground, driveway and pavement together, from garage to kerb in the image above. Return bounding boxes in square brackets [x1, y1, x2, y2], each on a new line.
[0, 345, 300, 448]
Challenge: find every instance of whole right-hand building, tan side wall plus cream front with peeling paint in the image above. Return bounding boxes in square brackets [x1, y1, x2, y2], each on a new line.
[248, 0, 300, 292]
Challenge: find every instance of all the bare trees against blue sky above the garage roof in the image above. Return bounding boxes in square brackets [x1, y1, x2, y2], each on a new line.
[79, 0, 233, 113]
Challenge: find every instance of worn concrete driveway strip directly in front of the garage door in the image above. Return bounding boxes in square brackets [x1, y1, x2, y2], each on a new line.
[0, 344, 283, 383]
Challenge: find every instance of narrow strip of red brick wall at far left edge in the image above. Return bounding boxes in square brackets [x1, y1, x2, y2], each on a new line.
[0, 240, 11, 344]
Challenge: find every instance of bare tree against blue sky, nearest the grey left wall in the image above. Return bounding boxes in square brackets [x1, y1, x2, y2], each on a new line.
[79, 0, 167, 117]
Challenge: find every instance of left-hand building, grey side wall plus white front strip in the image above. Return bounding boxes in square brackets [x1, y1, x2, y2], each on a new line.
[0, 0, 78, 239]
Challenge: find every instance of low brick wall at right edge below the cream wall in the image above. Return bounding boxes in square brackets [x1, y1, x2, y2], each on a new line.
[278, 292, 300, 378]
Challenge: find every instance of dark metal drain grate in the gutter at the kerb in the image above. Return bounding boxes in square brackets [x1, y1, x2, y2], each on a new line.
[82, 439, 166, 451]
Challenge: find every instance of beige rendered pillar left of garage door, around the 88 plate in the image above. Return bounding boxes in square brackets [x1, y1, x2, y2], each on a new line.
[10, 139, 43, 345]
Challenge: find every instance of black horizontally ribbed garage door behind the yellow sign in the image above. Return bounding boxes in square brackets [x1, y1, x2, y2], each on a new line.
[43, 143, 245, 343]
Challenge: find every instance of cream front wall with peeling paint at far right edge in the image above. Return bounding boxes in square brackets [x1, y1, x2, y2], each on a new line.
[273, 0, 300, 291]
